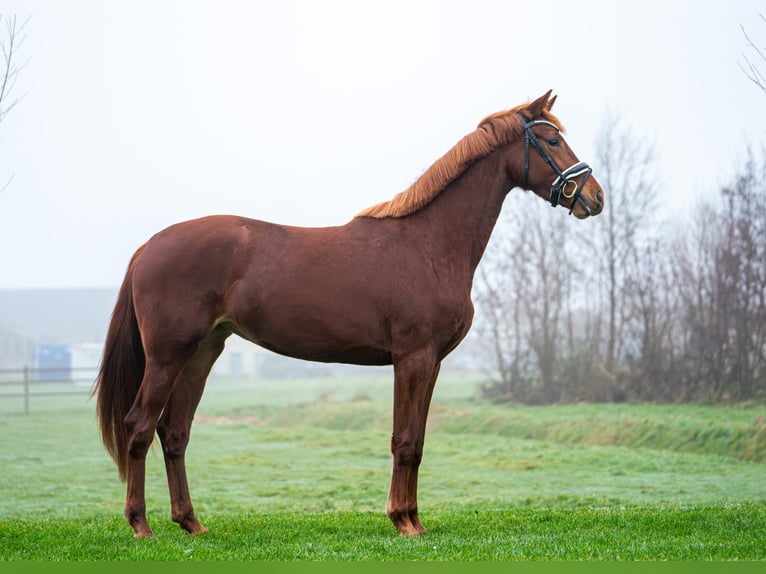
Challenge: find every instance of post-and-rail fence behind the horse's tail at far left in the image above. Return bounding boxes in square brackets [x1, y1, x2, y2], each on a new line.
[0, 367, 96, 414]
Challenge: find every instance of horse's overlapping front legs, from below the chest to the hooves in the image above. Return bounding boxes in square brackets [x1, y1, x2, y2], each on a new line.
[386, 349, 439, 536]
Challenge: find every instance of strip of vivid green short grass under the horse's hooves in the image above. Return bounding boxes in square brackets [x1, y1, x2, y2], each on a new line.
[0, 504, 766, 561]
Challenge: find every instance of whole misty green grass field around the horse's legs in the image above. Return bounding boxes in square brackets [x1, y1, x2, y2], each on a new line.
[0, 371, 766, 560]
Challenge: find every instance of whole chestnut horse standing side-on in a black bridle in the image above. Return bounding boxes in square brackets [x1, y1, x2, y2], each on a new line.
[93, 91, 604, 538]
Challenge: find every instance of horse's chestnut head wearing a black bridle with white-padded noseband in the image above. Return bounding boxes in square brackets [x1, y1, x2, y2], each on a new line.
[492, 90, 604, 219]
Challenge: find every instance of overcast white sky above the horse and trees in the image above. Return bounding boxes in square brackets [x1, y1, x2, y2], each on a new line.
[0, 0, 766, 288]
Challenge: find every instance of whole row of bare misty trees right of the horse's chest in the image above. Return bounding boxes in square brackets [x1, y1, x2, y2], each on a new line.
[474, 117, 766, 404]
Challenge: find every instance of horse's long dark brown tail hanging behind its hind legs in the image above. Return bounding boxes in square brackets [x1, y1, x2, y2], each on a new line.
[91, 247, 146, 481]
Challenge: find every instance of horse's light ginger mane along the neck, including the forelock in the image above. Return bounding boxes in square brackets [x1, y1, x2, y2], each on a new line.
[356, 104, 563, 219]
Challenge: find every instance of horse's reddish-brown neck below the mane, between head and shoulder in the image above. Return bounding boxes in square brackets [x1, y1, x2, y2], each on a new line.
[414, 154, 511, 277]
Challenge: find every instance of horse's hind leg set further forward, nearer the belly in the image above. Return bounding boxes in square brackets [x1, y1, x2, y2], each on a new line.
[157, 333, 228, 534]
